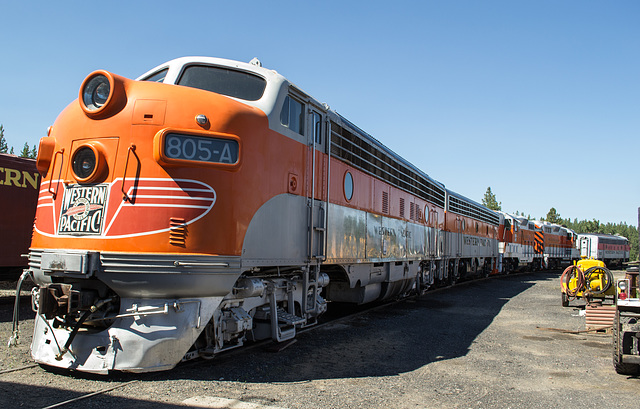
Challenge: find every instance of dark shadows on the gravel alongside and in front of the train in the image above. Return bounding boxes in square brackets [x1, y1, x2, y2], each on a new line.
[0, 273, 559, 408]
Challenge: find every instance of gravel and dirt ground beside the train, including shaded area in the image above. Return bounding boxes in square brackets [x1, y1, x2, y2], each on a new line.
[0, 272, 640, 409]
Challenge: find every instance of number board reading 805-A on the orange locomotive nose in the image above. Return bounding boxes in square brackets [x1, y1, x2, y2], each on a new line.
[164, 133, 240, 165]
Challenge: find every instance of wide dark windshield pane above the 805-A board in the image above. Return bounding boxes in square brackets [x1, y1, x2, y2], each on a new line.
[177, 65, 267, 101]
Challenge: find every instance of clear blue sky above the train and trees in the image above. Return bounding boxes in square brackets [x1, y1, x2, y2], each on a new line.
[0, 0, 640, 225]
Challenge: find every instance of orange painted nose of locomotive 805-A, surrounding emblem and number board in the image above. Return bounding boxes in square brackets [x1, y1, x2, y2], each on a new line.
[32, 79, 306, 256]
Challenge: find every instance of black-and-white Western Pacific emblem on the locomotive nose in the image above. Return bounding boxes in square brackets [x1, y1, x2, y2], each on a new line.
[58, 185, 108, 235]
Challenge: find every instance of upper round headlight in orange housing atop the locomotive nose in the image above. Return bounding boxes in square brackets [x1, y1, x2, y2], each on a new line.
[78, 70, 127, 118]
